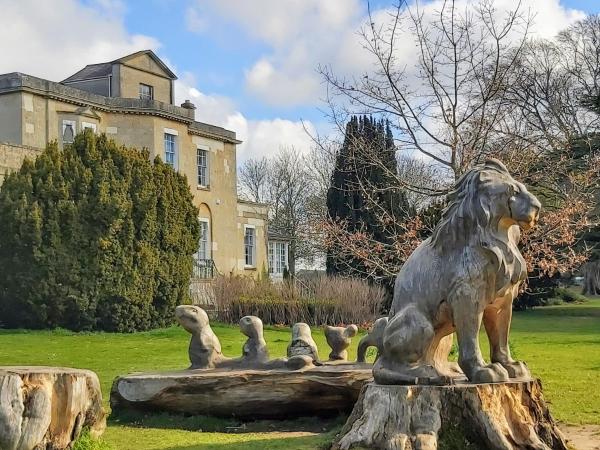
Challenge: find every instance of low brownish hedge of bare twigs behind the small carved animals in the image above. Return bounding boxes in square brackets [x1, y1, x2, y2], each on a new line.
[214, 276, 385, 325]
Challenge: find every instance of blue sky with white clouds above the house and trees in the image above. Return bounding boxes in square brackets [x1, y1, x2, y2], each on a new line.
[0, 0, 600, 162]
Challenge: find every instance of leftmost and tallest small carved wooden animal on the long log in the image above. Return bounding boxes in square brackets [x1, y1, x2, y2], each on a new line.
[175, 305, 227, 369]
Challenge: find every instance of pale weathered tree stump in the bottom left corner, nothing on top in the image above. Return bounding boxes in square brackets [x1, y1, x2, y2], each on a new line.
[0, 367, 106, 450]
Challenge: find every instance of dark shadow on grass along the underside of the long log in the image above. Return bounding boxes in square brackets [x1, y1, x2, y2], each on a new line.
[109, 411, 346, 433]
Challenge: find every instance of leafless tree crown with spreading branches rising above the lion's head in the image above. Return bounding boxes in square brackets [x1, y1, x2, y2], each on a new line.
[321, 0, 530, 178]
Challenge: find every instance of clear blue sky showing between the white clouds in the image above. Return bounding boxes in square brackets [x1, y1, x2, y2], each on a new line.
[125, 0, 600, 121]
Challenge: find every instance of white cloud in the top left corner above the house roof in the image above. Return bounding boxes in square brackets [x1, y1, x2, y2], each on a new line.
[0, 0, 160, 81]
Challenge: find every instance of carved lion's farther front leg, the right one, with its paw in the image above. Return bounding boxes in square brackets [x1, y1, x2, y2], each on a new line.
[483, 294, 531, 378]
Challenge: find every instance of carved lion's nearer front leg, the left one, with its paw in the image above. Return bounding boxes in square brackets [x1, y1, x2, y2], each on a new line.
[452, 296, 509, 383]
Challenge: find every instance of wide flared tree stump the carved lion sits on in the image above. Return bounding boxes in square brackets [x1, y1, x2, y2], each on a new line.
[333, 380, 567, 450]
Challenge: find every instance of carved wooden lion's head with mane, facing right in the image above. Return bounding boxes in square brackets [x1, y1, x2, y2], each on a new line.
[431, 159, 541, 253]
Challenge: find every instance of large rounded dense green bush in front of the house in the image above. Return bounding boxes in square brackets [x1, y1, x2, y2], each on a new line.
[0, 130, 199, 332]
